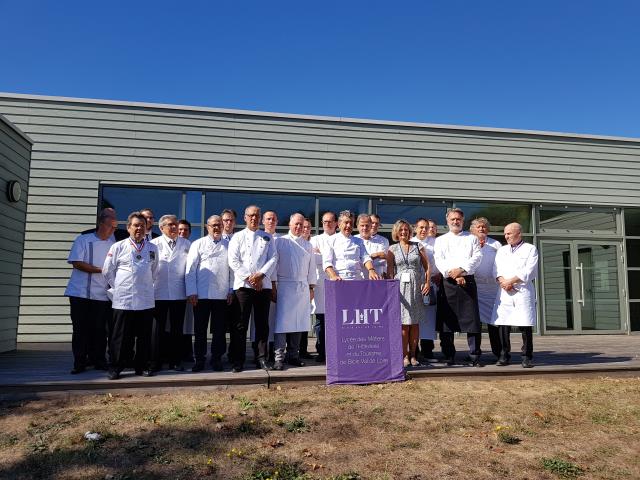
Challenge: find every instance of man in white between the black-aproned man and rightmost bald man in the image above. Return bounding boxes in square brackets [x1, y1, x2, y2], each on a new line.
[469, 217, 502, 357]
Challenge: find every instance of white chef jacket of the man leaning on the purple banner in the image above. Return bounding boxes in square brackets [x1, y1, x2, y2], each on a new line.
[322, 233, 371, 280]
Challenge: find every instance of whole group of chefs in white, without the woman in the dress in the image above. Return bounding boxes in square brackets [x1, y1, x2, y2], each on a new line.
[65, 205, 537, 380]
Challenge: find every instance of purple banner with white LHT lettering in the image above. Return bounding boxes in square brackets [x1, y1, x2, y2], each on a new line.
[324, 280, 405, 385]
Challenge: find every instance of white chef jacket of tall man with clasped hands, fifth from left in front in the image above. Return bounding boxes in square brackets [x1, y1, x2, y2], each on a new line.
[229, 228, 278, 290]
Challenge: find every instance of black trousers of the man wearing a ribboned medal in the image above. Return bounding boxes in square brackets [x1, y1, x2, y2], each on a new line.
[109, 308, 153, 372]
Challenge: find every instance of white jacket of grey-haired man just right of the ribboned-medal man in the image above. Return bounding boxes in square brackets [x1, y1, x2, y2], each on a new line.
[151, 235, 191, 300]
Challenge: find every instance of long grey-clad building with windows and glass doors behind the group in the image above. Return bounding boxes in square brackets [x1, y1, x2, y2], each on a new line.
[0, 94, 640, 342]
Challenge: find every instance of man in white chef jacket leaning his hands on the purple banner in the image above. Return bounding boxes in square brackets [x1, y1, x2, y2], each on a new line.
[322, 211, 381, 281]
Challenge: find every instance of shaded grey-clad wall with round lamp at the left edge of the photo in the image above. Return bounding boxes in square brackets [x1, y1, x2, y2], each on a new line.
[0, 115, 32, 352]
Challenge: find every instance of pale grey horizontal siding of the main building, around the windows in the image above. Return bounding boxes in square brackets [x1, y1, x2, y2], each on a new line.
[0, 95, 640, 341]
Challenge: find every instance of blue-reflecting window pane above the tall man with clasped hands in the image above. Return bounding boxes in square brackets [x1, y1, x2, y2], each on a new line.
[205, 192, 316, 230]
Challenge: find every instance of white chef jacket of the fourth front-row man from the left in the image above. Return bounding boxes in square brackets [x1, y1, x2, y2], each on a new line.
[185, 235, 233, 300]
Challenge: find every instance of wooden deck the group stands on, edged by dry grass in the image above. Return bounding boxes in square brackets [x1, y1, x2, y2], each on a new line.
[0, 335, 640, 397]
